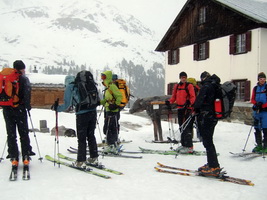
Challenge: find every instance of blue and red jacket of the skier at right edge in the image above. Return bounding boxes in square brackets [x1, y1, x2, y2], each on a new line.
[251, 83, 267, 108]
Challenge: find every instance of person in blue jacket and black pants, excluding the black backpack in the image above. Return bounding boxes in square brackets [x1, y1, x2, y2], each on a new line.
[52, 71, 100, 167]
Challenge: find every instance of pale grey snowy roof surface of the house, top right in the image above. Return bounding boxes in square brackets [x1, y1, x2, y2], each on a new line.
[216, 0, 267, 23]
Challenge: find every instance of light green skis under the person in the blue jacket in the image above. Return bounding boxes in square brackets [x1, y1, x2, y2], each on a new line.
[45, 154, 123, 179]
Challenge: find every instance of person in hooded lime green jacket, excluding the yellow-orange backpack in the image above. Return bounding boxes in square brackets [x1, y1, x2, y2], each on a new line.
[100, 71, 122, 153]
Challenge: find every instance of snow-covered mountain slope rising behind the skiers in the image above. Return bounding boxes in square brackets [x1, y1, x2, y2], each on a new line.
[0, 0, 164, 96]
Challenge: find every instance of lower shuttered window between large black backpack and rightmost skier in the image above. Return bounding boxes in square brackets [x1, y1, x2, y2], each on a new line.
[233, 79, 250, 101]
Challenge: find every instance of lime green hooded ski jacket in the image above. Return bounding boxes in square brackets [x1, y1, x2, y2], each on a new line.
[100, 71, 122, 112]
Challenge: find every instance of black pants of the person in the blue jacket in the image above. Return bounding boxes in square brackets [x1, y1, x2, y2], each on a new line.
[76, 111, 98, 162]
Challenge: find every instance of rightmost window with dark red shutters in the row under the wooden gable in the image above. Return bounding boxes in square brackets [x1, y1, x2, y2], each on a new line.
[229, 31, 251, 54]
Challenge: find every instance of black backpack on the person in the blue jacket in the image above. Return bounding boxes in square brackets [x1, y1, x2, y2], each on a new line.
[74, 70, 100, 112]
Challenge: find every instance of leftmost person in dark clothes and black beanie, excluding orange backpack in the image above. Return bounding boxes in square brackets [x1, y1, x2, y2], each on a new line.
[3, 60, 35, 165]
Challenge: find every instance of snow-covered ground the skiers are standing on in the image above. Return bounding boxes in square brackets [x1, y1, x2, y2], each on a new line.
[0, 109, 267, 200]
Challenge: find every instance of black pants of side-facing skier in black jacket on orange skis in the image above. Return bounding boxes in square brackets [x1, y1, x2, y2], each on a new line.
[197, 111, 220, 168]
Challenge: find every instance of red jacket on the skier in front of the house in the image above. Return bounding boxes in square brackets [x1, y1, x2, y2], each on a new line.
[169, 83, 196, 108]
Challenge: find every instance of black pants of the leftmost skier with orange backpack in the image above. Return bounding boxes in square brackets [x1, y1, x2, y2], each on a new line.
[3, 105, 32, 159]
